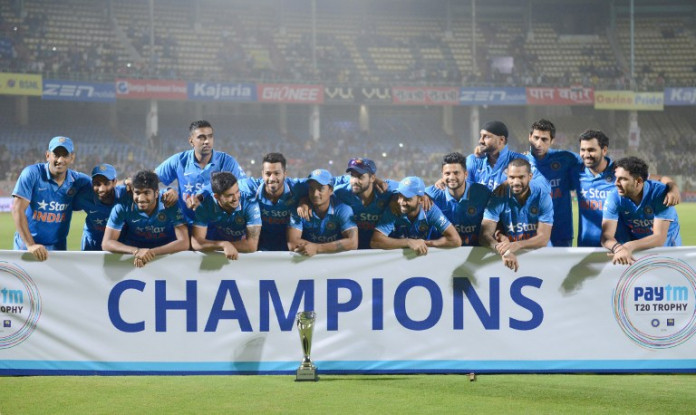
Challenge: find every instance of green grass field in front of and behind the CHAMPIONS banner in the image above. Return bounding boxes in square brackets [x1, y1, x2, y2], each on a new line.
[0, 203, 696, 415]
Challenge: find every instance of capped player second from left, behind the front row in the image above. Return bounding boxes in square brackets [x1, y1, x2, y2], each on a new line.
[73, 163, 132, 251]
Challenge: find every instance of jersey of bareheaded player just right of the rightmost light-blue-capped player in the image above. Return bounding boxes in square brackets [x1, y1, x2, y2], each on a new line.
[425, 183, 491, 246]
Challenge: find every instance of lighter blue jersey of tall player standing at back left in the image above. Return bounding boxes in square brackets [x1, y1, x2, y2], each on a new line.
[155, 150, 246, 224]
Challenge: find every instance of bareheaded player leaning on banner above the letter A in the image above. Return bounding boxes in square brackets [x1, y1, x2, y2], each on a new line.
[191, 172, 261, 259]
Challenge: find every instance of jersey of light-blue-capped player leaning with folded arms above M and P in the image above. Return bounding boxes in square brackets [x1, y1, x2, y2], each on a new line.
[290, 199, 357, 244]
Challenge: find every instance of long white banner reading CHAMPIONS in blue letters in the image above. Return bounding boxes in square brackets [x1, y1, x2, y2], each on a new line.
[0, 247, 696, 375]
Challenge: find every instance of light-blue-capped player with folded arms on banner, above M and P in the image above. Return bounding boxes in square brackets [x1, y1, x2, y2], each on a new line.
[288, 169, 358, 256]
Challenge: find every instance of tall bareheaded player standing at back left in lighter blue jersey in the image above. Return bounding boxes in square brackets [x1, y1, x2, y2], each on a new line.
[155, 120, 246, 224]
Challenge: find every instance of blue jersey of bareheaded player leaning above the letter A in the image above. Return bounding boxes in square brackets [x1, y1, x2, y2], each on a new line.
[193, 193, 261, 241]
